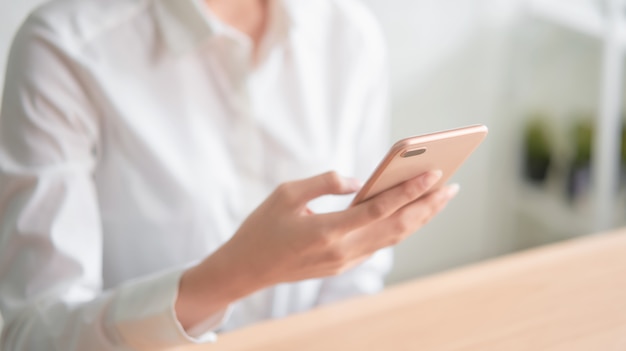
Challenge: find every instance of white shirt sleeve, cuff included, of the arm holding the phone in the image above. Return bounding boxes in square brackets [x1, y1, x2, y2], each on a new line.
[0, 13, 224, 351]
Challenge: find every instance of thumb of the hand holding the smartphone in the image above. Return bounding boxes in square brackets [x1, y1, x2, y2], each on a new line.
[279, 171, 361, 207]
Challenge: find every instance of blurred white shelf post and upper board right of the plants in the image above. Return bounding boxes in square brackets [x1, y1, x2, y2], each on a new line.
[526, 0, 626, 231]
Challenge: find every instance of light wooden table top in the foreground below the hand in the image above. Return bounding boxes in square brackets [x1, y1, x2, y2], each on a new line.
[178, 229, 626, 351]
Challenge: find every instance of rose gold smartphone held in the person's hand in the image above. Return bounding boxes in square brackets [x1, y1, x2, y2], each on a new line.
[351, 125, 487, 206]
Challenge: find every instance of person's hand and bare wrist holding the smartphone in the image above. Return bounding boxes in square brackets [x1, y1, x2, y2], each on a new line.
[176, 171, 458, 327]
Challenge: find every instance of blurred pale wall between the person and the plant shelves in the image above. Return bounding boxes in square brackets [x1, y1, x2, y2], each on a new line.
[366, 0, 520, 283]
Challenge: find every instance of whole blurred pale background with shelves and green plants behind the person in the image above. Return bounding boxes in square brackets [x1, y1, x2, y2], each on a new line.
[0, 0, 626, 332]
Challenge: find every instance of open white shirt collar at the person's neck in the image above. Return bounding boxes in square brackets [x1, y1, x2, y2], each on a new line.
[154, 0, 295, 54]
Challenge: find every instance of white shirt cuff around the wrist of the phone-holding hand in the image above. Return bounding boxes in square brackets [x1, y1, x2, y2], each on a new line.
[113, 269, 230, 350]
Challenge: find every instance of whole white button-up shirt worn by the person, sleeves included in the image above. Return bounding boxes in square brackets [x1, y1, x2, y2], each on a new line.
[0, 0, 391, 351]
